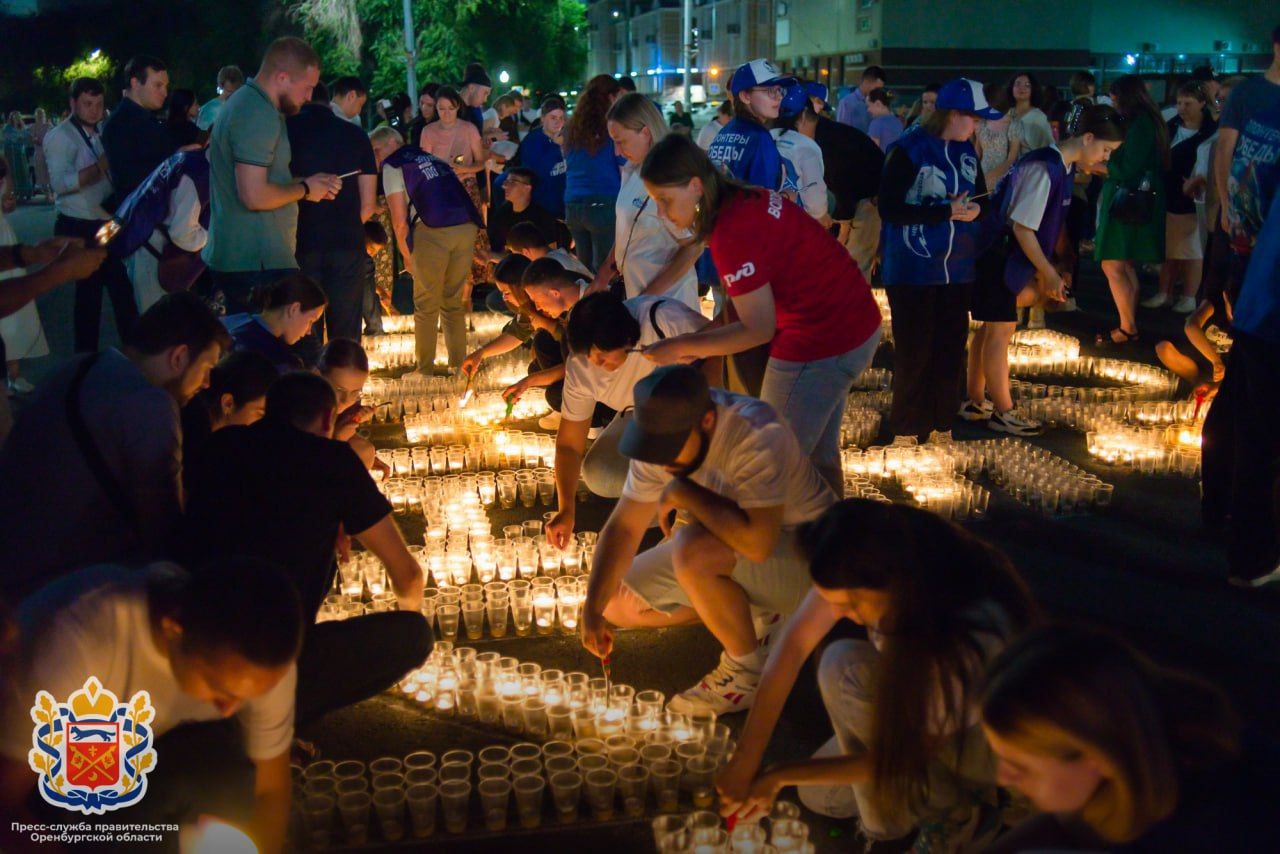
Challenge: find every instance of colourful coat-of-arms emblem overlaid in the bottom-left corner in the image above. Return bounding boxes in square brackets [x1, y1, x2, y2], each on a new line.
[27, 676, 156, 816]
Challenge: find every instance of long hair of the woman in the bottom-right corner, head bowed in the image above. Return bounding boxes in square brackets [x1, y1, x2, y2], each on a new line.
[982, 626, 1240, 842]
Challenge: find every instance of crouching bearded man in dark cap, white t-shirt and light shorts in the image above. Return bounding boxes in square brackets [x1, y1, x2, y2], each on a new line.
[582, 365, 836, 714]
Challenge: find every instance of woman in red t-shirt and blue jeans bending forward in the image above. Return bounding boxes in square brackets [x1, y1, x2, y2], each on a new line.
[640, 136, 881, 494]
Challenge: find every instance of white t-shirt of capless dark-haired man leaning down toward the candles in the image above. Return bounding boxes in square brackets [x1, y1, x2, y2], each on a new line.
[561, 297, 707, 421]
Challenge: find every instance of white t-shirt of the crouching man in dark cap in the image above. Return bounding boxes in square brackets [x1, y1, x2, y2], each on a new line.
[622, 384, 836, 528]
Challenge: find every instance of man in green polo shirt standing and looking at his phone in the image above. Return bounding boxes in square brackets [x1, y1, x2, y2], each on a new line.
[204, 37, 342, 315]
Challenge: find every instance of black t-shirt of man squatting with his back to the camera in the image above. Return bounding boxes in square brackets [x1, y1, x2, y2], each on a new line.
[178, 419, 392, 618]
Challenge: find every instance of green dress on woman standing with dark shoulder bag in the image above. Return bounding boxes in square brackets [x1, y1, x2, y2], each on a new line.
[1093, 113, 1165, 264]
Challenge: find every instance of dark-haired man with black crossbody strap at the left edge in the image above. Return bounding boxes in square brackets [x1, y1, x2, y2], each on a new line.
[0, 293, 230, 600]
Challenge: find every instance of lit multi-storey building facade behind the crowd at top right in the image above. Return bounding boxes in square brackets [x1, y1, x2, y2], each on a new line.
[588, 0, 1275, 100]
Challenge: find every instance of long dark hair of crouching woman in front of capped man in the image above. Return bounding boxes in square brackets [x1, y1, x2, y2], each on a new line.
[799, 499, 1038, 814]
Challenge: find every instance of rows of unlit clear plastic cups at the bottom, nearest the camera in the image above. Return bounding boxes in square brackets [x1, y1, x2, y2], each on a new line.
[293, 737, 750, 849]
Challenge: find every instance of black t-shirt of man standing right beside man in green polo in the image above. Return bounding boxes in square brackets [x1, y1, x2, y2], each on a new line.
[285, 104, 378, 252]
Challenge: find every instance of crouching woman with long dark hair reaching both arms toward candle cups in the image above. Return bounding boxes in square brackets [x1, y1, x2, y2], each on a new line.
[717, 499, 1037, 850]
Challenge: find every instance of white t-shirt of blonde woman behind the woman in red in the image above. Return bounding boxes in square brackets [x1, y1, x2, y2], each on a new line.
[613, 169, 698, 311]
